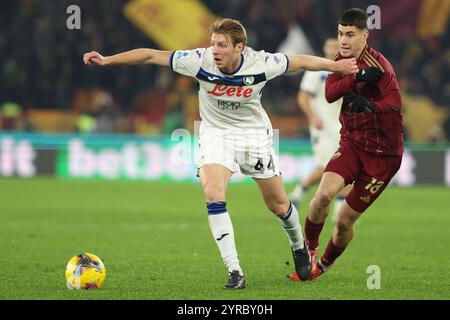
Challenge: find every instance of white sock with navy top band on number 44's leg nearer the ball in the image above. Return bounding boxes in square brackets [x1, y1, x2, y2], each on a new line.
[208, 202, 244, 275]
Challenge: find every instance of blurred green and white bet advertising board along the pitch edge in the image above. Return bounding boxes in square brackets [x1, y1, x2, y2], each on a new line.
[0, 134, 450, 186]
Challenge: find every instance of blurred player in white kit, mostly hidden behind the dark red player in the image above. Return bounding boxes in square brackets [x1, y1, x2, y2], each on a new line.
[289, 38, 351, 220]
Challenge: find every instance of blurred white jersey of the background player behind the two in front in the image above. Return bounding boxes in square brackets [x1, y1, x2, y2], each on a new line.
[300, 71, 342, 134]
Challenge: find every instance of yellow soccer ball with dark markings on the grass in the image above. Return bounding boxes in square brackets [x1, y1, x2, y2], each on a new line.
[66, 252, 106, 289]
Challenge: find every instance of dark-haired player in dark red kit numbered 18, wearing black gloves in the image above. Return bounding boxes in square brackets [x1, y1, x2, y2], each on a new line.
[305, 8, 403, 280]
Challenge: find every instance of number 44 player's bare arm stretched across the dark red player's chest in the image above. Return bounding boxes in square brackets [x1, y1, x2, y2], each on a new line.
[288, 55, 359, 75]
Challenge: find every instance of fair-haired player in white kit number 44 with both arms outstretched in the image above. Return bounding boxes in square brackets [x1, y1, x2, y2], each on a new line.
[83, 19, 358, 289]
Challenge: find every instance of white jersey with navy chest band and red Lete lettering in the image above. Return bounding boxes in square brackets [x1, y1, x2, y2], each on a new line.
[170, 47, 289, 130]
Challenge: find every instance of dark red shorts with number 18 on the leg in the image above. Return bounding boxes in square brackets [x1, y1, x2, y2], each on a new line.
[325, 141, 402, 212]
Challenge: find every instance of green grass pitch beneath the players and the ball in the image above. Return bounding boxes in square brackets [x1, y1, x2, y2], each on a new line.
[0, 178, 450, 300]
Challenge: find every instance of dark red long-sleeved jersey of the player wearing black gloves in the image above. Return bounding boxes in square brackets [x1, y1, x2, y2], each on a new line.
[325, 46, 403, 156]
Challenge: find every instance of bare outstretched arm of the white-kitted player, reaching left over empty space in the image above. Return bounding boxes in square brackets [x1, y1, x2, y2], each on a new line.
[83, 49, 172, 67]
